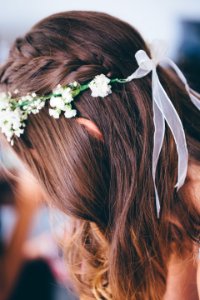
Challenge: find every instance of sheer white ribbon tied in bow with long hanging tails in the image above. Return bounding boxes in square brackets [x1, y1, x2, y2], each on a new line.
[126, 43, 200, 218]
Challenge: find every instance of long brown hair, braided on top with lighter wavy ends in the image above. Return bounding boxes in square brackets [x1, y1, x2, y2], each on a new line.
[0, 11, 200, 300]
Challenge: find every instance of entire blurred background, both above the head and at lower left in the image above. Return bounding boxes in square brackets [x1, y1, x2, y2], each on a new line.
[0, 0, 200, 300]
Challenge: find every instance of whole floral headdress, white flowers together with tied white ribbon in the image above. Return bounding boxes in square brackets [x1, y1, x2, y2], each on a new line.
[0, 42, 200, 217]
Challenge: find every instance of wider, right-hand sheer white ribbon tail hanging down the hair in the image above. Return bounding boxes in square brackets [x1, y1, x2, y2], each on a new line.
[153, 69, 188, 189]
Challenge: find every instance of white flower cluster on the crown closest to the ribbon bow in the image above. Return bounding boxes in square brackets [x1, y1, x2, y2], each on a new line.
[88, 74, 112, 98]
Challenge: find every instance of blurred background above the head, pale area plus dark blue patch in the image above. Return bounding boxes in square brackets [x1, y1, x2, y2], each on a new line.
[0, 0, 200, 88]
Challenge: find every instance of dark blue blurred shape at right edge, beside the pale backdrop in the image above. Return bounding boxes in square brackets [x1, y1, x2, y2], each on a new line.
[176, 20, 200, 92]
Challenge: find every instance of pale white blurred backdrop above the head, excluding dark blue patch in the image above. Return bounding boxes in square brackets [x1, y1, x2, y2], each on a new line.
[0, 0, 200, 62]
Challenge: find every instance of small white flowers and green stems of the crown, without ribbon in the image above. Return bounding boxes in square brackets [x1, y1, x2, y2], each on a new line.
[0, 74, 125, 145]
